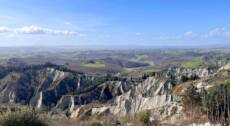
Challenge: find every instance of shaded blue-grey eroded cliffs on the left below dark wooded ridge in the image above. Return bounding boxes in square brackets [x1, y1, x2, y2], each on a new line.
[0, 65, 137, 111]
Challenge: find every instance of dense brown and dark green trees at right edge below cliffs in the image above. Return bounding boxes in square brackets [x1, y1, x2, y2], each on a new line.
[182, 84, 230, 125]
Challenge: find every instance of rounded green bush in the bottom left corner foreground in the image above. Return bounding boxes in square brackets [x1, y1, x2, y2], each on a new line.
[0, 108, 51, 126]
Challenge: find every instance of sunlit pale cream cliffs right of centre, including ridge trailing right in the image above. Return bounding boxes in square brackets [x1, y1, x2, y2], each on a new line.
[110, 67, 216, 115]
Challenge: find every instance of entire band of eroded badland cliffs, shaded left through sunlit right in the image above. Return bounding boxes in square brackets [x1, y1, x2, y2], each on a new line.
[0, 65, 217, 124]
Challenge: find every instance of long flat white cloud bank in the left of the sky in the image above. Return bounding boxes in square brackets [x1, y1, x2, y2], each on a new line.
[0, 25, 82, 35]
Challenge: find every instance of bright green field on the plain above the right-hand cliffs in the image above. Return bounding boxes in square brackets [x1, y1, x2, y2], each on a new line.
[181, 59, 203, 69]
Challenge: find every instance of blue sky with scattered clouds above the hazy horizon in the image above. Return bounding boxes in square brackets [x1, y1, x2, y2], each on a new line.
[0, 0, 230, 46]
